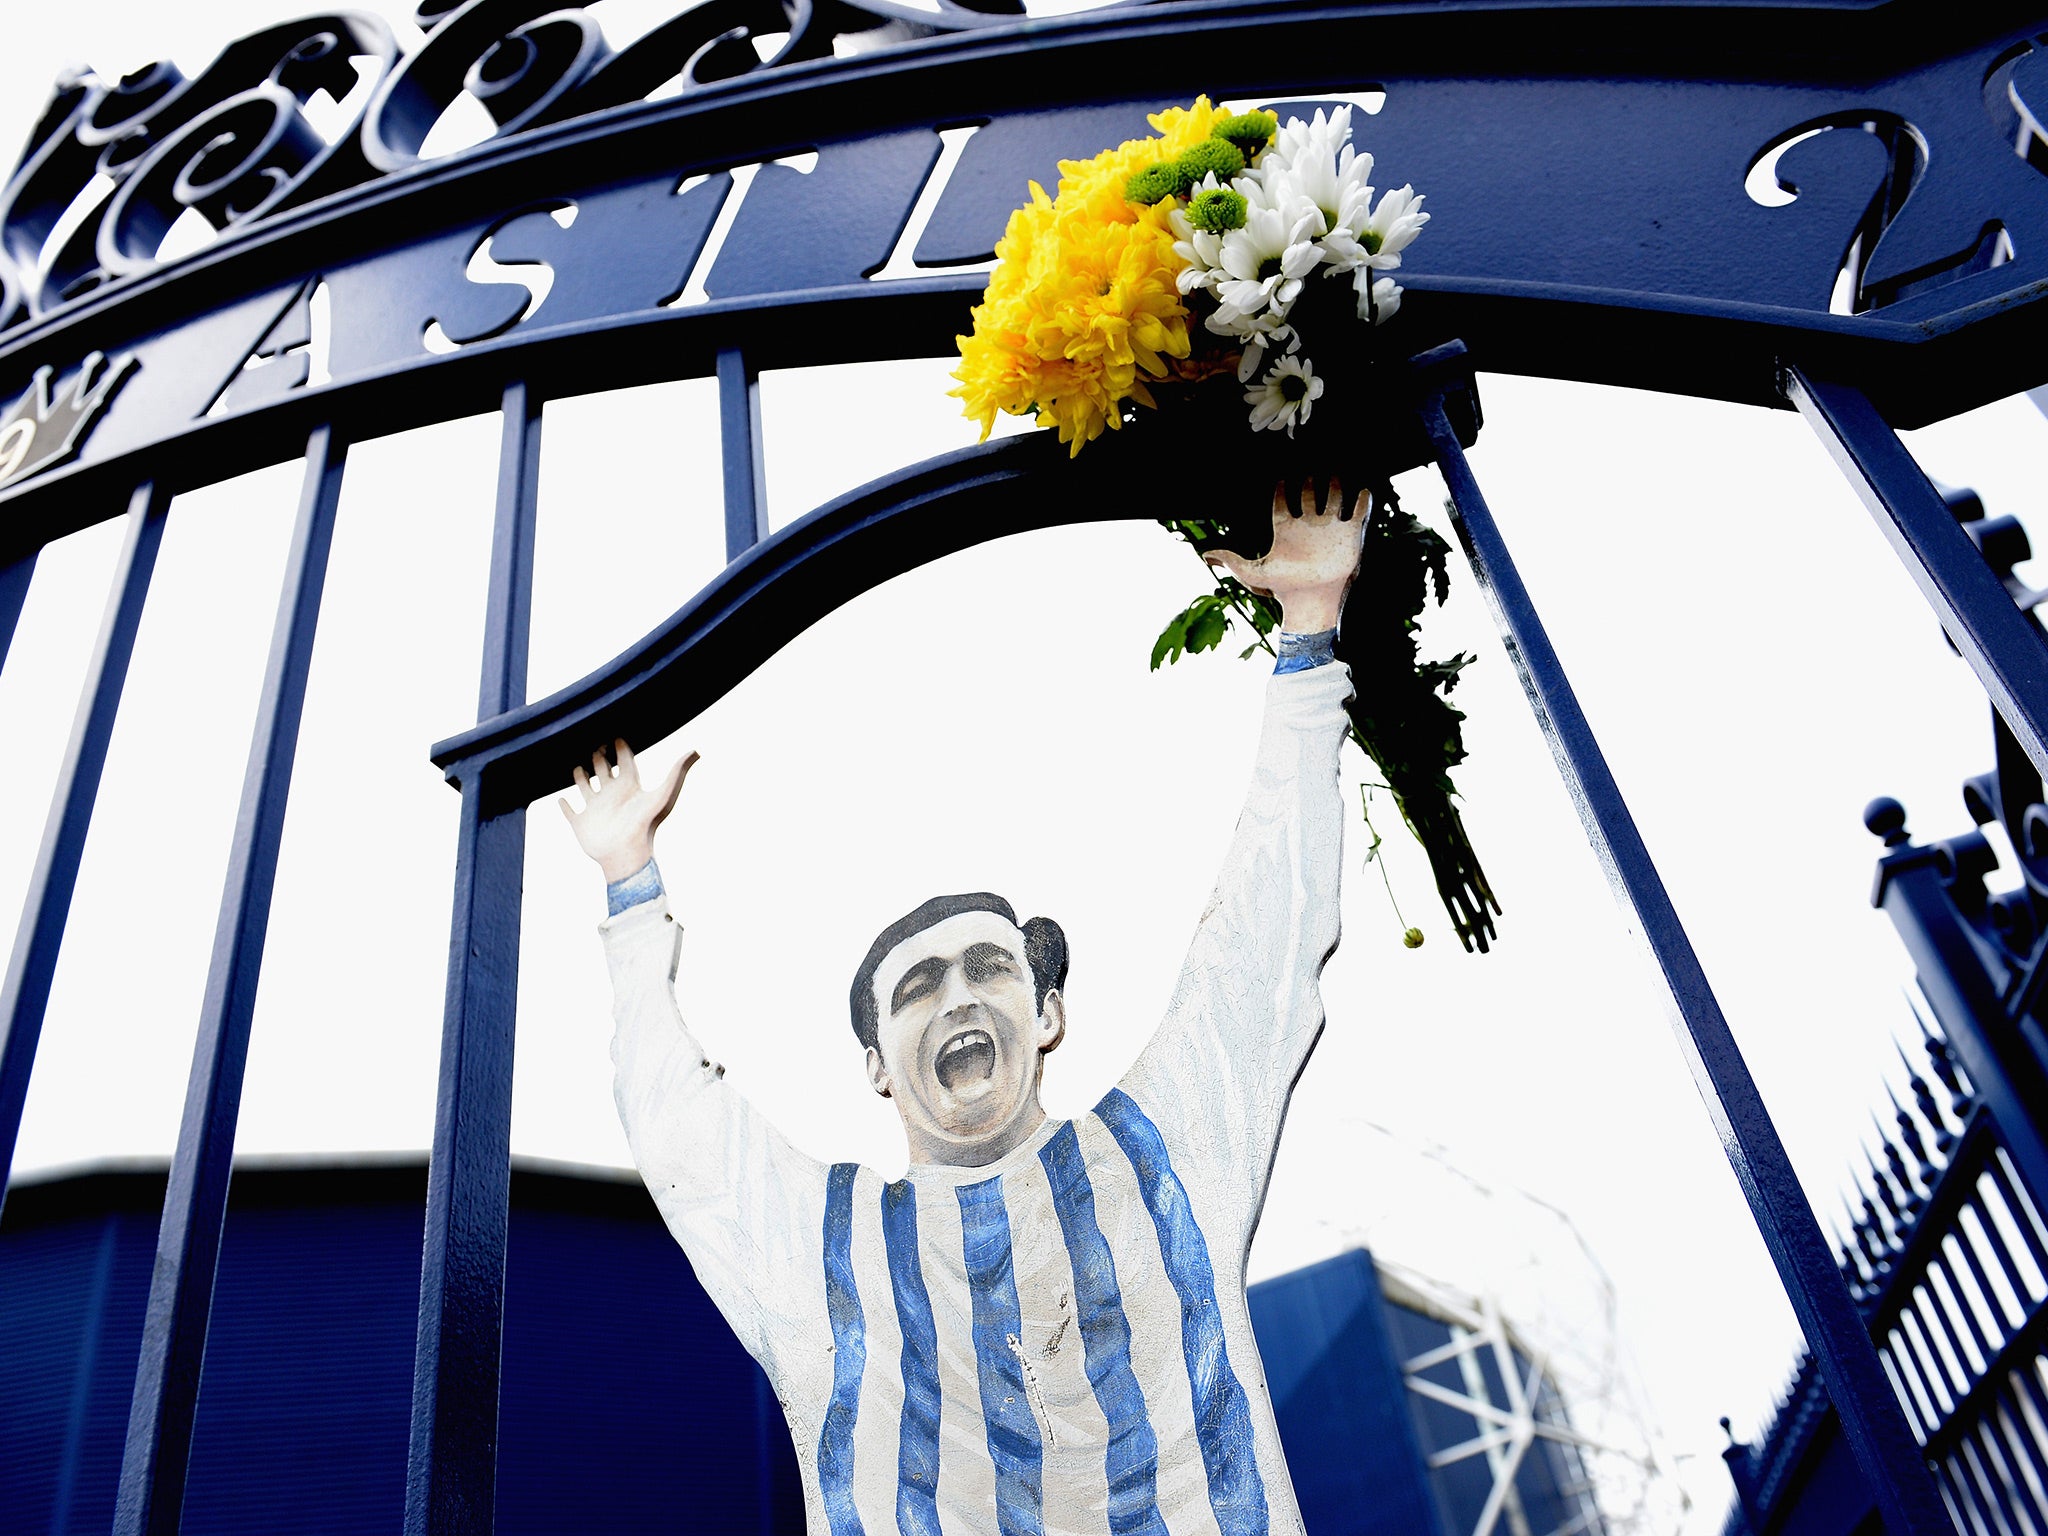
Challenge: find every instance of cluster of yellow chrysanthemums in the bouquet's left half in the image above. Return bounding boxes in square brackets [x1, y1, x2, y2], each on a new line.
[950, 96, 1221, 453]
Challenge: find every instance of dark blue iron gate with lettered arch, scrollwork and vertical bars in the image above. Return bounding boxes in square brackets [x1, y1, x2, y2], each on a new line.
[0, 0, 2048, 1534]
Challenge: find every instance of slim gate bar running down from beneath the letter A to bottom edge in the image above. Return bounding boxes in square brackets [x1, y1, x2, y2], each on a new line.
[115, 428, 348, 1536]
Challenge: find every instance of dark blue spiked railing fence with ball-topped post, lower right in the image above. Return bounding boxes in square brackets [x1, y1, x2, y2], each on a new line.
[1726, 937, 2048, 1536]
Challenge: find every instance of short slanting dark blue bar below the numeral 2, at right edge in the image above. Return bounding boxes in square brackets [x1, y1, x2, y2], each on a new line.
[1786, 369, 2048, 774]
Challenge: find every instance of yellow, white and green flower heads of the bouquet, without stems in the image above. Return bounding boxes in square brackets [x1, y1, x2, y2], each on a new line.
[952, 96, 1430, 453]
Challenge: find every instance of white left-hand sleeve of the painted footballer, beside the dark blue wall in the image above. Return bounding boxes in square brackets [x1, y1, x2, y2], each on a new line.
[598, 897, 825, 1397]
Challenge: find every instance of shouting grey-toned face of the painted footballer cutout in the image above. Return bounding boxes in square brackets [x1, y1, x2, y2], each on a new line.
[868, 911, 1067, 1167]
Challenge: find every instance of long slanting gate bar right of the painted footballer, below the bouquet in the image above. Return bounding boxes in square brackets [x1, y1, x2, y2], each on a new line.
[1423, 382, 1941, 1536]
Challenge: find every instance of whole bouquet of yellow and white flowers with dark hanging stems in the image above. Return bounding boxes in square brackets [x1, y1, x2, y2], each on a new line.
[950, 96, 1499, 950]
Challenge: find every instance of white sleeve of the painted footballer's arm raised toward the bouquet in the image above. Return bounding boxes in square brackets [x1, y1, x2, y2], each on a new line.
[1124, 662, 1352, 1237]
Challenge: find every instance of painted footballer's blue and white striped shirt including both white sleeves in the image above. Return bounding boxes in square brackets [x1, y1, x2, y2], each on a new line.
[604, 666, 1350, 1536]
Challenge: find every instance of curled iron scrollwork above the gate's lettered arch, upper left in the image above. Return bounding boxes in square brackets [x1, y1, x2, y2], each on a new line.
[0, 0, 1138, 332]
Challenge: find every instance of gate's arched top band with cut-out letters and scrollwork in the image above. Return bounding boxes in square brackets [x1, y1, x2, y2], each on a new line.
[0, 0, 2048, 520]
